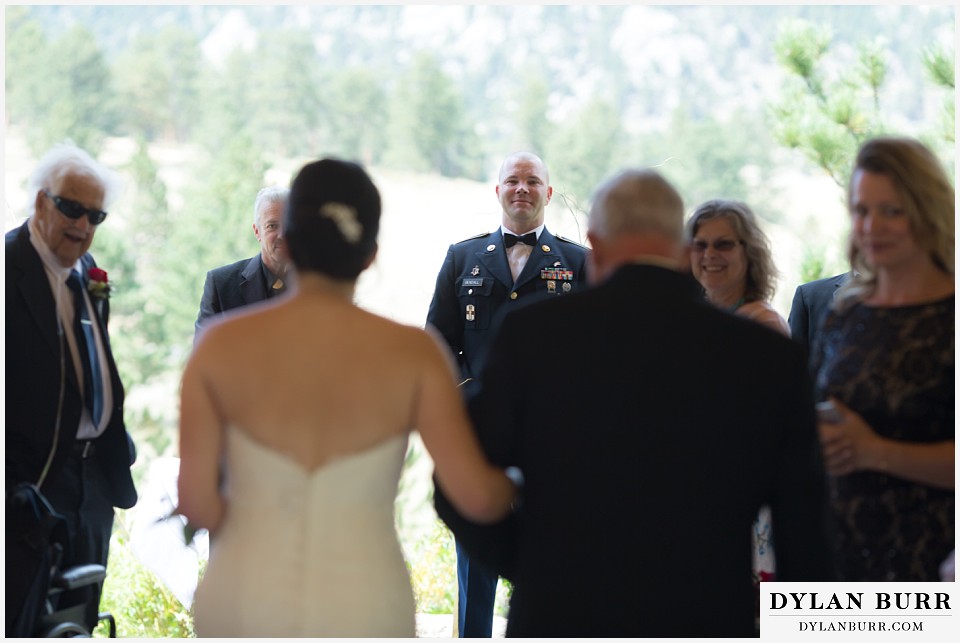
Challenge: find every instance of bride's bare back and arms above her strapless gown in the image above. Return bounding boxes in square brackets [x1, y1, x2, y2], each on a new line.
[180, 275, 512, 528]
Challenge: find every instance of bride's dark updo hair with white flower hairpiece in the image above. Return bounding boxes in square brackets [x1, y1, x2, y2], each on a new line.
[283, 159, 380, 281]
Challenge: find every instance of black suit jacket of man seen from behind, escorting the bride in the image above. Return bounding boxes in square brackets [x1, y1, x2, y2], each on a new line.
[435, 265, 831, 637]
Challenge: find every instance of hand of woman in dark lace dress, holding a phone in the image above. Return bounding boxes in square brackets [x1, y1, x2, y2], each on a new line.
[817, 397, 884, 476]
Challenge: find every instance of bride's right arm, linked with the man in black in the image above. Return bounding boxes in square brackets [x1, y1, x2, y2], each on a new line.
[414, 328, 516, 523]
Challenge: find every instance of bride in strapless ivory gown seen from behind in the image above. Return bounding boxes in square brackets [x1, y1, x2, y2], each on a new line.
[178, 159, 516, 637]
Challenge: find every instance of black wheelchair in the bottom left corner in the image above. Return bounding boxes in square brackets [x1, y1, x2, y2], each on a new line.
[6, 484, 117, 638]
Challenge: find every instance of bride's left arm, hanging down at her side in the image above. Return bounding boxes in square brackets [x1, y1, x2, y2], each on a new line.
[177, 350, 224, 534]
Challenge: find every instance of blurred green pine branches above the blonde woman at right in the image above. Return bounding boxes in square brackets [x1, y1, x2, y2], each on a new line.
[770, 14, 955, 281]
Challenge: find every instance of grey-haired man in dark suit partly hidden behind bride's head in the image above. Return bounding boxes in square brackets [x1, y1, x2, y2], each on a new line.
[194, 186, 290, 341]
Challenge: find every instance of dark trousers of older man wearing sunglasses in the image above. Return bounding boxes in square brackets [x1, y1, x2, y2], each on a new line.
[43, 451, 113, 627]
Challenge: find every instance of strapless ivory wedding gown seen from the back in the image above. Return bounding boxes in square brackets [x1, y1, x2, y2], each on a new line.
[194, 428, 416, 638]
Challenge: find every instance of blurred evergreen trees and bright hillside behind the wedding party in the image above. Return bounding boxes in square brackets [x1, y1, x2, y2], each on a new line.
[4, 5, 955, 632]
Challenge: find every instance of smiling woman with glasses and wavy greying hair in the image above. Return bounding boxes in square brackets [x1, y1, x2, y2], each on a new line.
[686, 199, 790, 617]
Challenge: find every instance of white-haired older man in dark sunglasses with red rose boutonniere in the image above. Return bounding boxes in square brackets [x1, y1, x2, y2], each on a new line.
[5, 144, 137, 635]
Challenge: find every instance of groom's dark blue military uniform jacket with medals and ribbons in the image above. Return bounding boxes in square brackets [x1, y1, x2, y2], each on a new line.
[427, 227, 587, 398]
